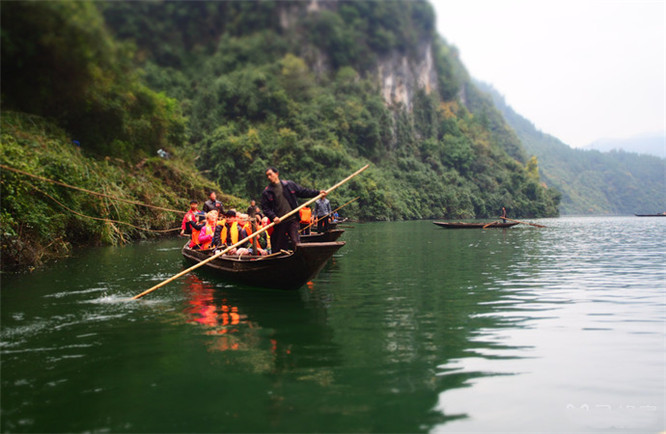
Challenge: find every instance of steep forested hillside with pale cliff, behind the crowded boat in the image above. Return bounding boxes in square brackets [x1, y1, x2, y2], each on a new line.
[104, 1, 559, 220]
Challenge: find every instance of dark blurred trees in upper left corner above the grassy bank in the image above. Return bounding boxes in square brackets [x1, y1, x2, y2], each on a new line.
[2, 1, 185, 158]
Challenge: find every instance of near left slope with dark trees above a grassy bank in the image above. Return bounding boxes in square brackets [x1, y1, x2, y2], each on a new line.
[0, 2, 240, 272]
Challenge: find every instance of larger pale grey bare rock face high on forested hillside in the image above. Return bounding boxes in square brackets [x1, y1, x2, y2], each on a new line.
[377, 40, 437, 112]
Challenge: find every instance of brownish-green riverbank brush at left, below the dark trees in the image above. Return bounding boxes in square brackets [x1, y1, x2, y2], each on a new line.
[0, 111, 244, 271]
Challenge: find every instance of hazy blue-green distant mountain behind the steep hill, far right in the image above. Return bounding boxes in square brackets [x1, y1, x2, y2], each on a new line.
[476, 82, 666, 215]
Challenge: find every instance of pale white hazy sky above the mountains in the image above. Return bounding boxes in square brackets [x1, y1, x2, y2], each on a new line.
[430, 0, 666, 147]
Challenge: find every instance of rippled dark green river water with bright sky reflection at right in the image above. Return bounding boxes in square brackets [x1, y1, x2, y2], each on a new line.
[0, 217, 666, 433]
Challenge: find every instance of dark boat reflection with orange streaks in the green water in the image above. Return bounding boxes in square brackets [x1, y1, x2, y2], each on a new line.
[183, 274, 341, 373]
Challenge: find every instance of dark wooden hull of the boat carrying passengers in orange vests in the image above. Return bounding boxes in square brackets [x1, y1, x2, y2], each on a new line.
[181, 241, 345, 289]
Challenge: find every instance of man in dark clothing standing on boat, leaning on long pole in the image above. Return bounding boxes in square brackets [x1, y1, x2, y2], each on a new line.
[261, 167, 326, 252]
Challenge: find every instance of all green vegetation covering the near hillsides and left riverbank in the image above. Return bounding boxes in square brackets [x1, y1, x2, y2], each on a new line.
[0, 0, 559, 263]
